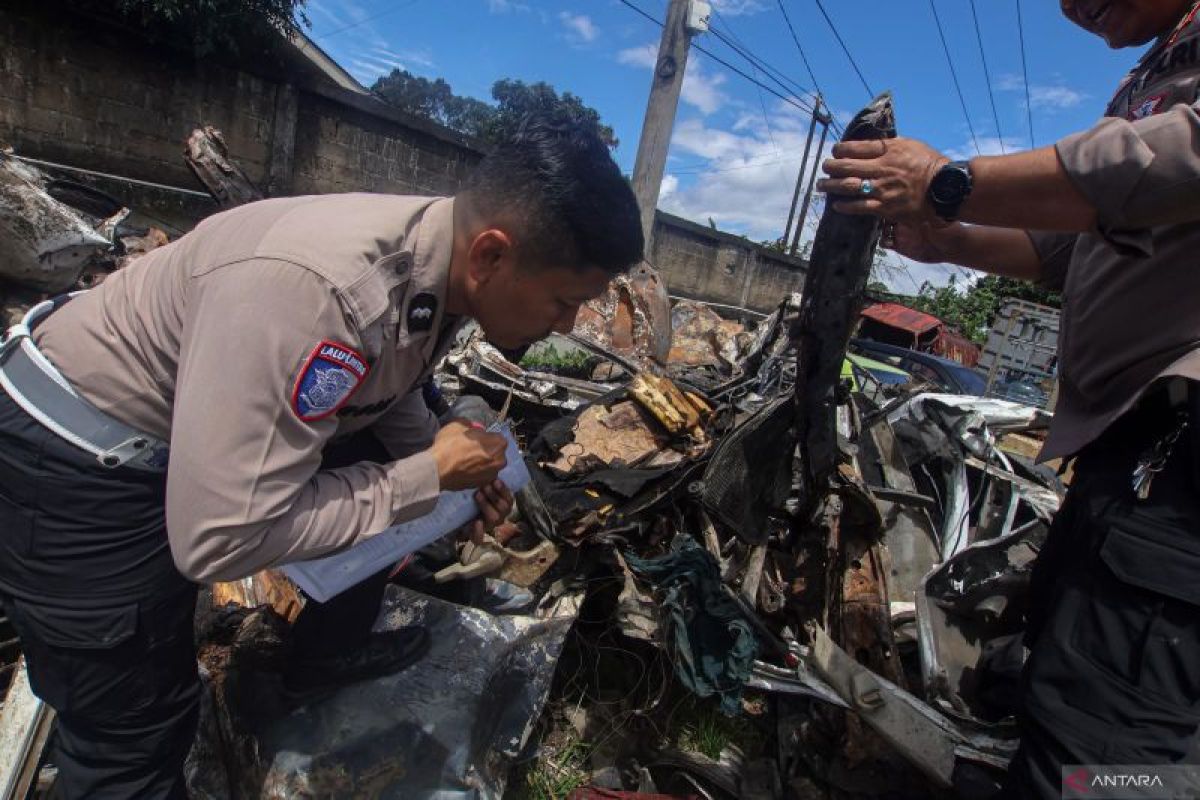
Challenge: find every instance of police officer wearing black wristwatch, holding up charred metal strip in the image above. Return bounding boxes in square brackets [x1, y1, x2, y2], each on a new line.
[822, 0, 1200, 798]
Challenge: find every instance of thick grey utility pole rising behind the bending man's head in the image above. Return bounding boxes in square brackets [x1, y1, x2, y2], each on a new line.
[634, 0, 703, 257]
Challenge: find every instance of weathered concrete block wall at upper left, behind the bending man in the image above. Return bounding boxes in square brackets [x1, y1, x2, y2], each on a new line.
[0, 0, 481, 203]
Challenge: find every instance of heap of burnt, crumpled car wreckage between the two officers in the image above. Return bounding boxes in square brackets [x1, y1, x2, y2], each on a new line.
[0, 95, 1062, 800]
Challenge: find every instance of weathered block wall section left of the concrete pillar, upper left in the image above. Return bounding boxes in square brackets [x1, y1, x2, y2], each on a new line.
[0, 2, 276, 188]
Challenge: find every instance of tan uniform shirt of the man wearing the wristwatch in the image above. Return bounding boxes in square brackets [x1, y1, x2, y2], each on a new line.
[1030, 6, 1200, 459]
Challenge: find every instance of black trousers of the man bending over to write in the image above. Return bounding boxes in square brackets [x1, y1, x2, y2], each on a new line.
[0, 391, 386, 800]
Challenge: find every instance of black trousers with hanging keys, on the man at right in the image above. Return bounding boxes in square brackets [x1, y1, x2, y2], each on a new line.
[1007, 408, 1200, 800]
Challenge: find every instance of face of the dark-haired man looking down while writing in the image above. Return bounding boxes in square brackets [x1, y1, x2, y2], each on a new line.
[472, 256, 611, 349]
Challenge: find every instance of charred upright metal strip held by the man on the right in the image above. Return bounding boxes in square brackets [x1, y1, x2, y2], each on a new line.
[792, 92, 895, 505]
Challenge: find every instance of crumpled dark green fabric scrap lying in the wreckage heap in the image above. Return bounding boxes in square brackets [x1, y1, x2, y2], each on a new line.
[625, 536, 758, 715]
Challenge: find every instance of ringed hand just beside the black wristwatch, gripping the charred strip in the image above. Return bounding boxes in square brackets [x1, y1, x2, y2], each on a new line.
[817, 138, 949, 223]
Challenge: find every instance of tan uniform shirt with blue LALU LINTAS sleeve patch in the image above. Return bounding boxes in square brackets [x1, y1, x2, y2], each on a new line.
[36, 194, 458, 581]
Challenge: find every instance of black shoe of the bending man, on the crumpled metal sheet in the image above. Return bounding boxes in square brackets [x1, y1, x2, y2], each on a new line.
[283, 626, 430, 700]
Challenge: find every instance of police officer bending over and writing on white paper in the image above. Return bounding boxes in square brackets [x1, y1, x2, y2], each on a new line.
[0, 121, 642, 800]
